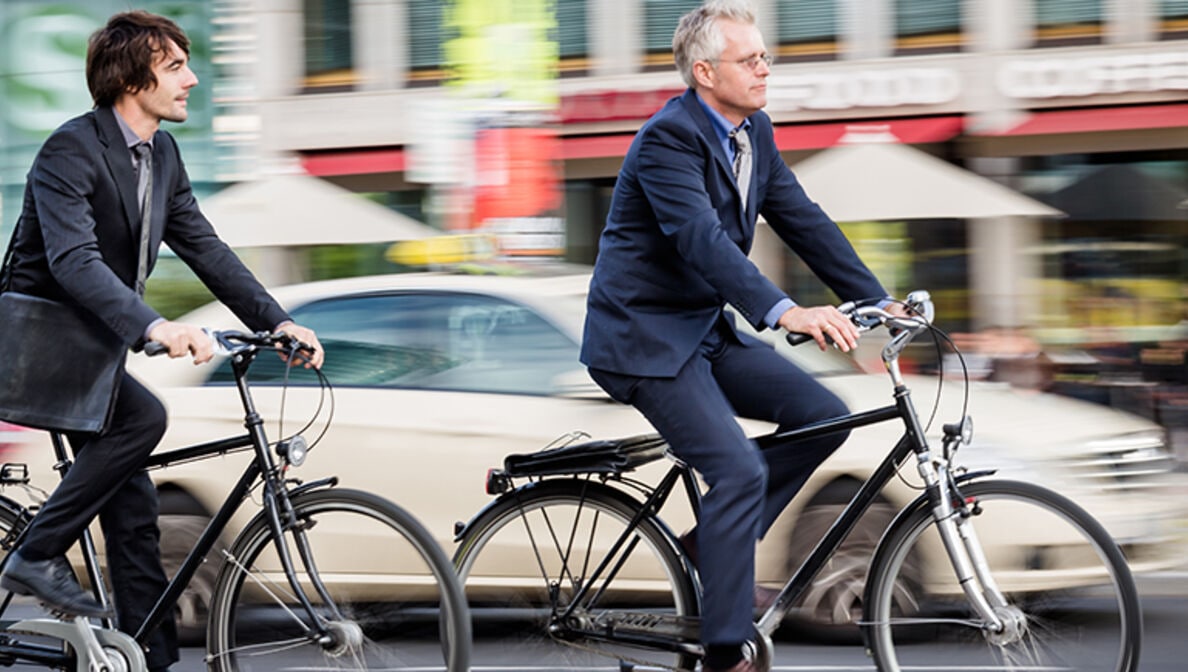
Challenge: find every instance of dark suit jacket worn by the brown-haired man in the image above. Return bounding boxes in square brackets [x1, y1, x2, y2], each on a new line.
[11, 108, 289, 345]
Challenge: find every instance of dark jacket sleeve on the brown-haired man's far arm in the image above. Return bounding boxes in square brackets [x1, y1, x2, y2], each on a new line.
[160, 134, 289, 331]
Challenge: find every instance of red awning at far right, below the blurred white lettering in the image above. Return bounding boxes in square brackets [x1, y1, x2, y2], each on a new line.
[982, 104, 1188, 137]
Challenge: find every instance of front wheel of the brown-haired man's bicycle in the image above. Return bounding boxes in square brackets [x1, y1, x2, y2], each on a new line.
[207, 488, 470, 672]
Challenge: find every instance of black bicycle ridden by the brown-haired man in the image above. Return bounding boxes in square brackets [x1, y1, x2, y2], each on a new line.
[0, 331, 470, 672]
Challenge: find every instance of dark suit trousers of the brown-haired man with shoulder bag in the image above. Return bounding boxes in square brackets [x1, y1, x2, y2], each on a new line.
[20, 374, 178, 670]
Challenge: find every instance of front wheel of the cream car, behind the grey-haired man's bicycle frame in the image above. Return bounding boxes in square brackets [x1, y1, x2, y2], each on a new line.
[785, 481, 918, 644]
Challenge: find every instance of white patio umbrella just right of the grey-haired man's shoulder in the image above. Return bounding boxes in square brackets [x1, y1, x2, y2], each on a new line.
[792, 133, 1062, 222]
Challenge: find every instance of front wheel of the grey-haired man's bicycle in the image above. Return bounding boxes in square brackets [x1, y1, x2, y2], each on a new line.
[865, 481, 1143, 672]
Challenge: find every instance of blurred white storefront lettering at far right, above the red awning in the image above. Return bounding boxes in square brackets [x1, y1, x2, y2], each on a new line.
[998, 51, 1188, 99]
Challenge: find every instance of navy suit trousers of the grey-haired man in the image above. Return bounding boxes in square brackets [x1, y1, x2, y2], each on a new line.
[590, 324, 848, 646]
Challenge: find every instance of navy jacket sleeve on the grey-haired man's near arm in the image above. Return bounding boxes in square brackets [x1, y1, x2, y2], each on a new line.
[638, 122, 784, 329]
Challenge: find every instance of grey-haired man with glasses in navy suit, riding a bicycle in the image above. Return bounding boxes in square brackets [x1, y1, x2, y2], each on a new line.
[582, 0, 902, 672]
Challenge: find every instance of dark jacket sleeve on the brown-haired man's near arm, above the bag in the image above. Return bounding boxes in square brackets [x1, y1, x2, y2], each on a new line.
[30, 132, 160, 345]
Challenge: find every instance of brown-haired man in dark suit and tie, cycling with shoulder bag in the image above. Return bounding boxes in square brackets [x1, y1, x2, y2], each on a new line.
[0, 11, 322, 671]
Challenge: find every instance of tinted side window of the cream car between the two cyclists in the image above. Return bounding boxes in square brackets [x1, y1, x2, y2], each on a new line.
[211, 292, 580, 394]
